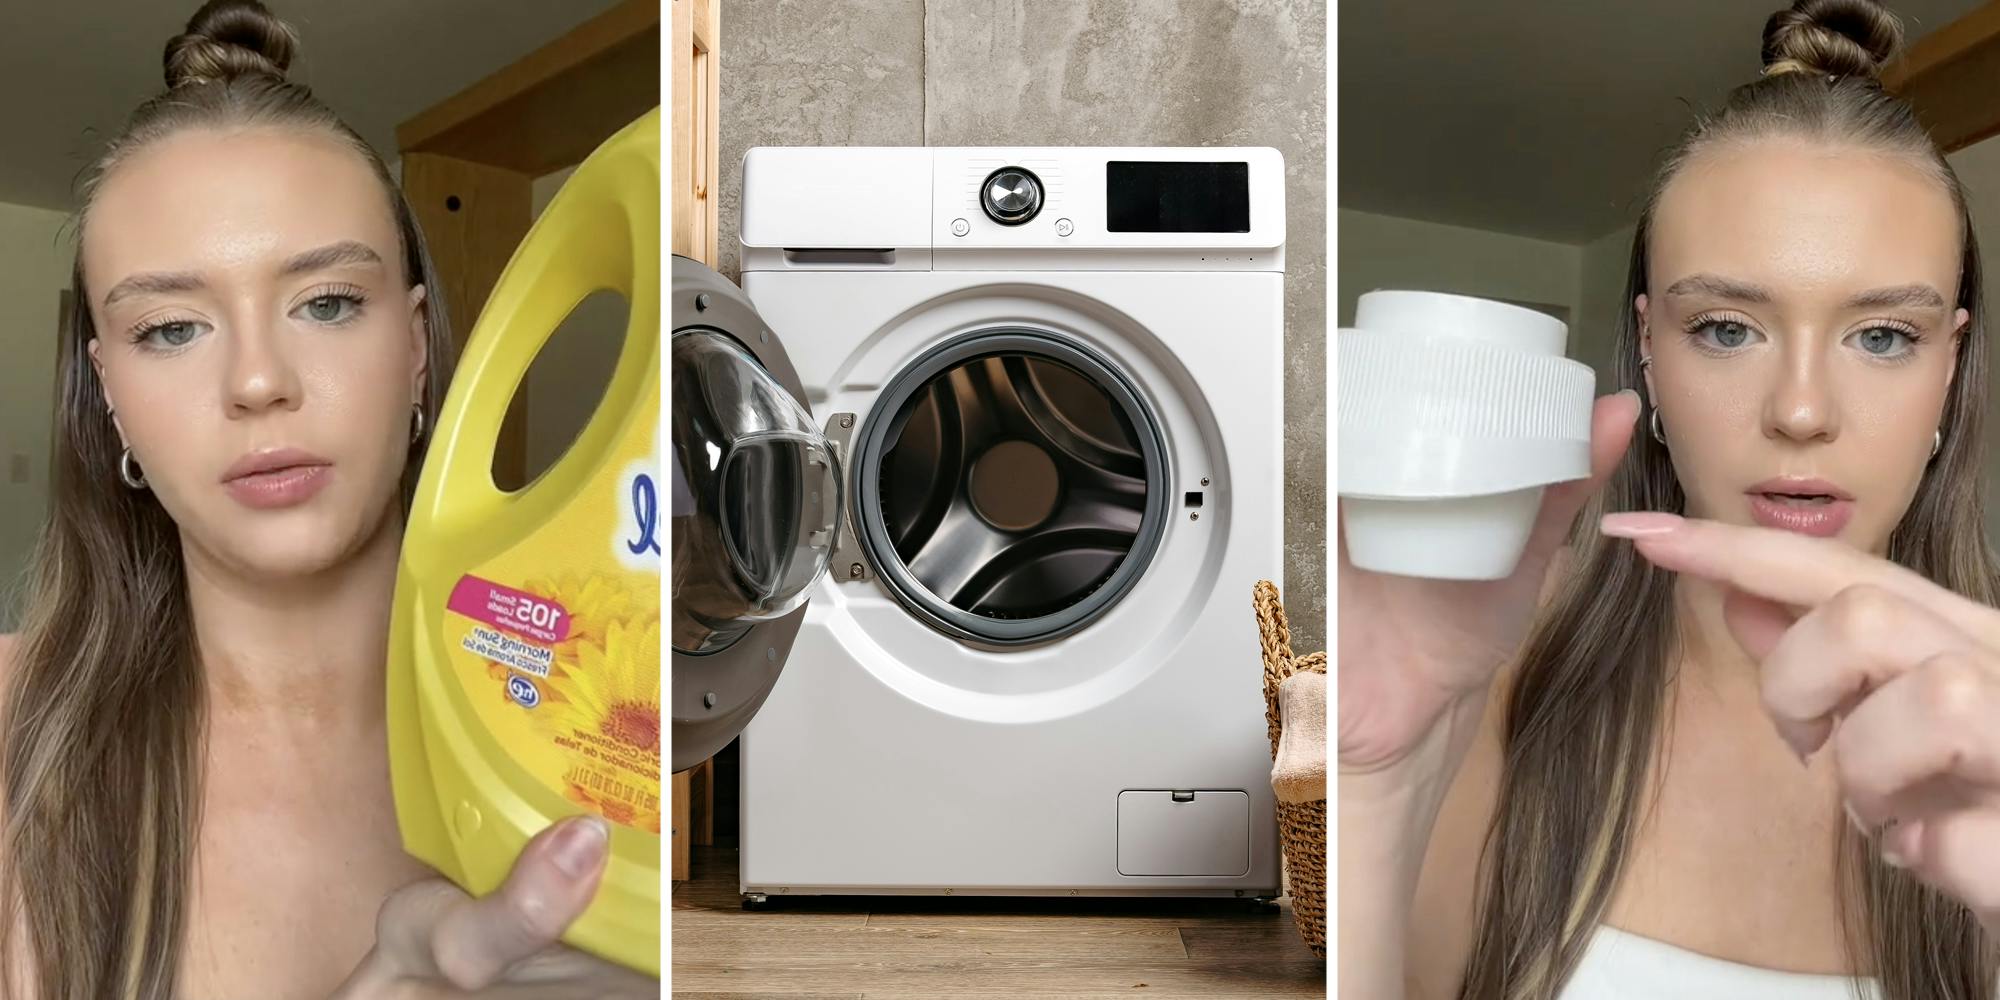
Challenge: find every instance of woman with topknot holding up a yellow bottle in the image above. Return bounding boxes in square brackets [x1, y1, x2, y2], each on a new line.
[0, 0, 658, 1000]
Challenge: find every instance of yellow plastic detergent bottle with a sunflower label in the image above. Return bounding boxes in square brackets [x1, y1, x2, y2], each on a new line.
[388, 108, 662, 976]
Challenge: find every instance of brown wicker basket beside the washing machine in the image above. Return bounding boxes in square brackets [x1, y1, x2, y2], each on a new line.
[1252, 580, 1326, 958]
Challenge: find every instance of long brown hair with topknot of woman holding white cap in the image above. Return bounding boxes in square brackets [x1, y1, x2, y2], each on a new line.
[1458, 0, 2000, 1000]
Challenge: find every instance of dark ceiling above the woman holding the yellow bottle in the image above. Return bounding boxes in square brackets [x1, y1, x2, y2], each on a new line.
[0, 0, 614, 210]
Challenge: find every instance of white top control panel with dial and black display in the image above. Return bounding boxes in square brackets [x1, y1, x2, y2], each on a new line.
[738, 146, 1284, 270]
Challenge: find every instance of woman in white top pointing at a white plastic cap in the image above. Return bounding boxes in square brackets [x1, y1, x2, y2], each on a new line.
[1338, 0, 2000, 1000]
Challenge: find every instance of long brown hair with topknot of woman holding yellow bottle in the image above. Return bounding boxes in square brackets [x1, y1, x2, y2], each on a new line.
[0, 0, 452, 1000]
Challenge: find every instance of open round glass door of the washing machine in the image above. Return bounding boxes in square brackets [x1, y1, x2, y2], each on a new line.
[668, 256, 842, 772]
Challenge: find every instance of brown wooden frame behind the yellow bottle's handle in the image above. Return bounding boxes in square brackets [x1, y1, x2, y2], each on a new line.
[396, 0, 660, 486]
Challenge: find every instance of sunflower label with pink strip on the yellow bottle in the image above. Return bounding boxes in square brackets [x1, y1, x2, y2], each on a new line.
[446, 402, 662, 834]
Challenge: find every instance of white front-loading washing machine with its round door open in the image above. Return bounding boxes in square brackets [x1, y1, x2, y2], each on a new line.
[676, 148, 1284, 904]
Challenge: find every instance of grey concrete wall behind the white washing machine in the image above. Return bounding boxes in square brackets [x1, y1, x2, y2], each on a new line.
[720, 0, 1326, 652]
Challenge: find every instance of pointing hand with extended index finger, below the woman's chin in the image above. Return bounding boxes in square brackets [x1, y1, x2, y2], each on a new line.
[1604, 514, 2000, 934]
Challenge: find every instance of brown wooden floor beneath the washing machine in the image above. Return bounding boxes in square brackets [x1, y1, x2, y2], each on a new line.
[670, 838, 1326, 1000]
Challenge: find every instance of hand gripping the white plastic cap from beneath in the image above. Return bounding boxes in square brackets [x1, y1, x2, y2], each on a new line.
[1334, 392, 1640, 776]
